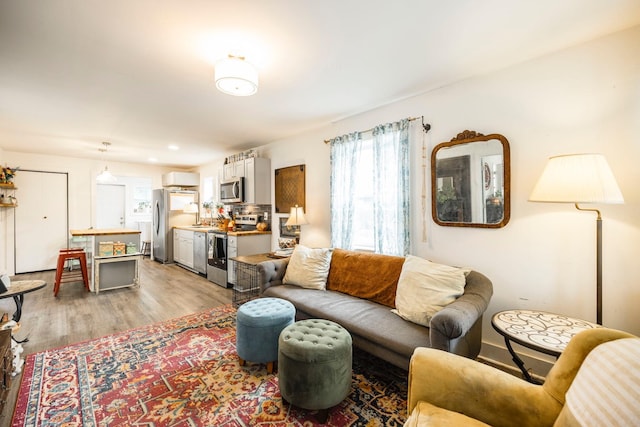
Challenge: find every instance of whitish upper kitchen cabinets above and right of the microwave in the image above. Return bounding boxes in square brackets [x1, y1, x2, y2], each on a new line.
[222, 157, 271, 205]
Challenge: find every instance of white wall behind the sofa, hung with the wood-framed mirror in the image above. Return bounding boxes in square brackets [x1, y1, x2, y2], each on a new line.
[208, 27, 640, 372]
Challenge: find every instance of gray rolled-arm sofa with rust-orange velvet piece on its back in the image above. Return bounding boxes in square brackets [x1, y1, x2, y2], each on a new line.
[258, 249, 493, 370]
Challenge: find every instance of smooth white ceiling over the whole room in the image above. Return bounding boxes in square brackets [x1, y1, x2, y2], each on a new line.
[0, 0, 640, 167]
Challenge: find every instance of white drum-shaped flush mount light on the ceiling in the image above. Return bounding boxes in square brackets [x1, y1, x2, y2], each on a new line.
[215, 55, 258, 96]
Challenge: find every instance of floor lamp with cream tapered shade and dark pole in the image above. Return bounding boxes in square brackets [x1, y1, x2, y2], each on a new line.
[529, 154, 624, 325]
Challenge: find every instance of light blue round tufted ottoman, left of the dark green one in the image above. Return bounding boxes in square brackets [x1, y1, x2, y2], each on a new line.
[236, 298, 296, 373]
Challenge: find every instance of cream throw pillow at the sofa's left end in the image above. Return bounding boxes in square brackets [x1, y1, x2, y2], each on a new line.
[282, 245, 333, 290]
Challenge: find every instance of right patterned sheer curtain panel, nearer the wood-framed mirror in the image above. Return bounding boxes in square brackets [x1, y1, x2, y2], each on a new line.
[373, 119, 411, 256]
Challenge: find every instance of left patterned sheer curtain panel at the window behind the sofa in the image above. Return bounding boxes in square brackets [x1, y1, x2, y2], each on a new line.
[330, 132, 362, 249]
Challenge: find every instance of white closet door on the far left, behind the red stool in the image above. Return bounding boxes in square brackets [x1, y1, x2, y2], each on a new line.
[14, 170, 69, 274]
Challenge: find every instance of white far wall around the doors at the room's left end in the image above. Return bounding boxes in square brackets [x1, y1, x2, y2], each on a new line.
[0, 151, 188, 274]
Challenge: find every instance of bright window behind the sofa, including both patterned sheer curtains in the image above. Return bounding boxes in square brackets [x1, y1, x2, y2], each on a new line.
[331, 120, 410, 255]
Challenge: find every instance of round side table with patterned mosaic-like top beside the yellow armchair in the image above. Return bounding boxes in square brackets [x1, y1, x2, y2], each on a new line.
[491, 310, 601, 383]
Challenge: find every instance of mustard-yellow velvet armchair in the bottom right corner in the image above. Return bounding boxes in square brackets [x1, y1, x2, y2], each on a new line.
[405, 328, 640, 427]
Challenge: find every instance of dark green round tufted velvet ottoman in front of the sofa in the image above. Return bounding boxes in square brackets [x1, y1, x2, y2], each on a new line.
[278, 319, 352, 422]
